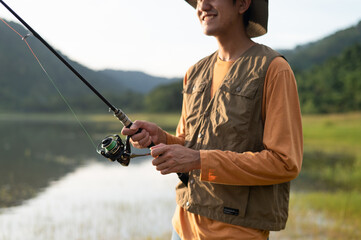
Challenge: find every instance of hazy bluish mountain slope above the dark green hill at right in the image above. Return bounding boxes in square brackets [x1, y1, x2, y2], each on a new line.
[279, 21, 361, 72]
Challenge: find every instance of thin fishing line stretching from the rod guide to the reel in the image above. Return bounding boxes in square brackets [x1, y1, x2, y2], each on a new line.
[0, 18, 97, 149]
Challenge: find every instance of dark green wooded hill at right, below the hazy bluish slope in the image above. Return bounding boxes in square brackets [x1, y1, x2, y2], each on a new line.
[296, 44, 361, 113]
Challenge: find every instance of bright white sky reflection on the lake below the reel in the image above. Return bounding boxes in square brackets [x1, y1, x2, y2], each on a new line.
[0, 160, 178, 240]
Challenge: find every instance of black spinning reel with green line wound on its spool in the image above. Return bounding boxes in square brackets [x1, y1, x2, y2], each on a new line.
[97, 134, 131, 166]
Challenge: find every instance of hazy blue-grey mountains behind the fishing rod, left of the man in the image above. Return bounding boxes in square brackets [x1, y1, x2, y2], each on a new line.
[0, 19, 174, 111]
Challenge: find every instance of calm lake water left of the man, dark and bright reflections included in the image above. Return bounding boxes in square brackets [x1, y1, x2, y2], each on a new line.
[0, 114, 178, 240]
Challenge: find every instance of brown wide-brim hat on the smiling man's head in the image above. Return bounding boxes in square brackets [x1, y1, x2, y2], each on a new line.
[185, 0, 268, 38]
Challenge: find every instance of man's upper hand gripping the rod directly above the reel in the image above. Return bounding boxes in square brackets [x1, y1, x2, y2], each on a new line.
[122, 121, 167, 148]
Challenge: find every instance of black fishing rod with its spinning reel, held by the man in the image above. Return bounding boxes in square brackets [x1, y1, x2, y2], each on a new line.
[0, 0, 189, 186]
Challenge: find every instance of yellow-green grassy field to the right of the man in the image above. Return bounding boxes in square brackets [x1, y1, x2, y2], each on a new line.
[273, 113, 361, 239]
